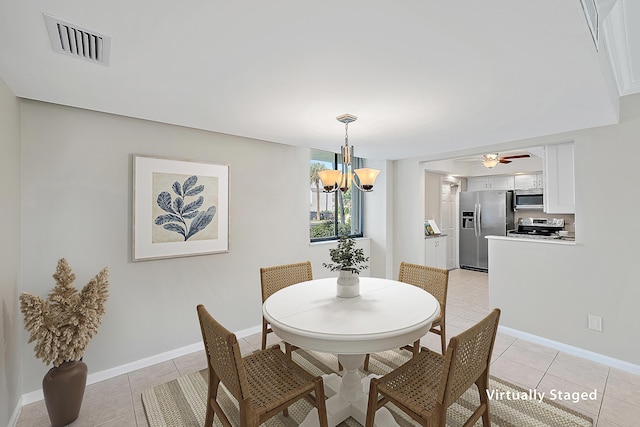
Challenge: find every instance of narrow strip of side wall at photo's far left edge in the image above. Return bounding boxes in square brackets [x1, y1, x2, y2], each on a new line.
[0, 75, 21, 425]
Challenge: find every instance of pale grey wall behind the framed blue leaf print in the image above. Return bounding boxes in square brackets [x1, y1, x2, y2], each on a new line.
[20, 100, 386, 393]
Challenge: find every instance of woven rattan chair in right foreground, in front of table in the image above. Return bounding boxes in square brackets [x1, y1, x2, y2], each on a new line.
[365, 308, 500, 427]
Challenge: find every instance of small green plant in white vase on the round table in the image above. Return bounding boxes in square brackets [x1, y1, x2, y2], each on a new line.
[322, 235, 369, 298]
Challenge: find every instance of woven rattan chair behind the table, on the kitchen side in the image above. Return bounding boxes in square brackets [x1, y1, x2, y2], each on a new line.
[398, 262, 449, 355]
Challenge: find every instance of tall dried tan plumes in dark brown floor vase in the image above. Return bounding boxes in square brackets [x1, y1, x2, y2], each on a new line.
[20, 258, 109, 427]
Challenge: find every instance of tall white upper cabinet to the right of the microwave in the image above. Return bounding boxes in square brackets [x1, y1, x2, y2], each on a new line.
[543, 142, 576, 214]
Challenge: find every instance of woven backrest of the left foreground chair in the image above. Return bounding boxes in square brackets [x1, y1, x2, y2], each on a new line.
[197, 304, 249, 401]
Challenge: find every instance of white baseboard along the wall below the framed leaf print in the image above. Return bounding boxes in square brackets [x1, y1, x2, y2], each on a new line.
[16, 325, 262, 406]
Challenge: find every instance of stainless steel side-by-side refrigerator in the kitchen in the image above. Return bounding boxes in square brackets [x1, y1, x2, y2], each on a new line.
[459, 190, 514, 271]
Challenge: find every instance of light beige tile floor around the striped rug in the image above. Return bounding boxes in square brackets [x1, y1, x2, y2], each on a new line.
[17, 270, 640, 427]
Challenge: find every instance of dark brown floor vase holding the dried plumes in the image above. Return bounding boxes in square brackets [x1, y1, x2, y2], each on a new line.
[42, 360, 87, 427]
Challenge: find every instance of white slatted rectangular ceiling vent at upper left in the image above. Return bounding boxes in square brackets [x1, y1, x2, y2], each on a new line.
[44, 14, 111, 65]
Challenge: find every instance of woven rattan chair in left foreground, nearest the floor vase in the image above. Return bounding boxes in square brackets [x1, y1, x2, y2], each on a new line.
[197, 304, 327, 427]
